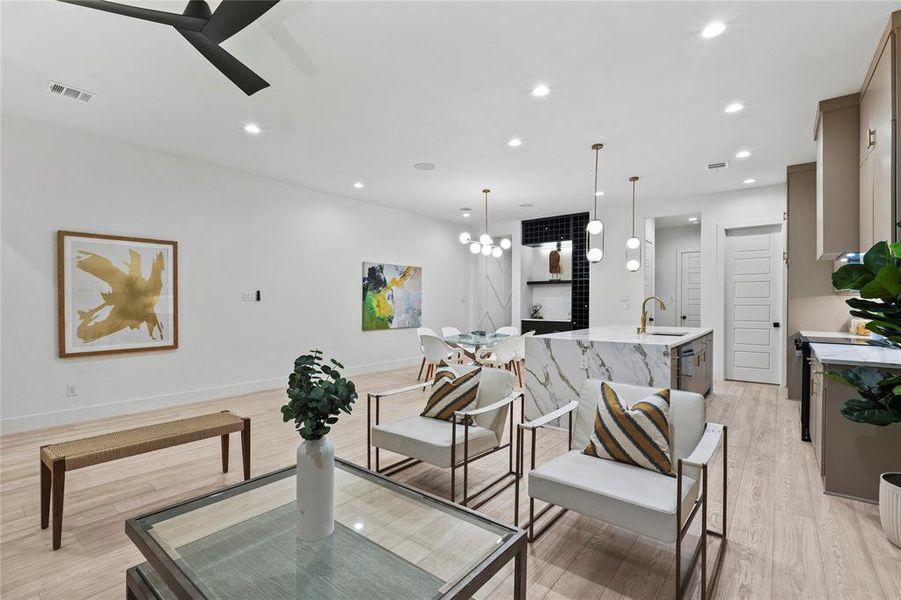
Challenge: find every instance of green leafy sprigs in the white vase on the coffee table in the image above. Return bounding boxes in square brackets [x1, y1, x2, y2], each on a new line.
[282, 350, 357, 441]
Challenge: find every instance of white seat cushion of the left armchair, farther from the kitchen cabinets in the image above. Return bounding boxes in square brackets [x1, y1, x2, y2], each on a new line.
[372, 416, 500, 468]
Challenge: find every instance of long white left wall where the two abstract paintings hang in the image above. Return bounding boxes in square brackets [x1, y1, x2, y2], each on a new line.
[0, 115, 474, 431]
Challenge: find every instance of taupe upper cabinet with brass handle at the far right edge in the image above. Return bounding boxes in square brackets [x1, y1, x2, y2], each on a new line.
[858, 12, 901, 250]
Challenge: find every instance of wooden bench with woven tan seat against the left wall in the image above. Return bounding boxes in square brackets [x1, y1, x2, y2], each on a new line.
[41, 411, 250, 550]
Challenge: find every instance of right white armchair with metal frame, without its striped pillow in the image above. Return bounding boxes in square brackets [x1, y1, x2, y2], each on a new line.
[513, 379, 727, 598]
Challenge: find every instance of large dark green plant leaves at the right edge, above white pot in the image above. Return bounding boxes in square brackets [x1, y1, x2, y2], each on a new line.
[827, 223, 901, 426]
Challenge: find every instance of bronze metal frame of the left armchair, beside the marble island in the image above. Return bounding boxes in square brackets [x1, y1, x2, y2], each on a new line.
[366, 381, 525, 509]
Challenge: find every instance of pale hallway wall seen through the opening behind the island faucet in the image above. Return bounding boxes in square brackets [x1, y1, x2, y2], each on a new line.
[654, 224, 701, 327]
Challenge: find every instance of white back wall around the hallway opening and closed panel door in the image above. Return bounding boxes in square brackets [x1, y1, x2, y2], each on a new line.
[589, 184, 785, 379]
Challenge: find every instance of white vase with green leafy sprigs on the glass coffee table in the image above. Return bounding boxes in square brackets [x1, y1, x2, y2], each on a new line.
[282, 350, 357, 541]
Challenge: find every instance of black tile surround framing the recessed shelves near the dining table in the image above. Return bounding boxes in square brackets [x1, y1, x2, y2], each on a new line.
[522, 212, 588, 329]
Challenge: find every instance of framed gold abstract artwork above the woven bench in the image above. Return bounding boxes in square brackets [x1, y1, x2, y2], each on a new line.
[57, 231, 178, 358]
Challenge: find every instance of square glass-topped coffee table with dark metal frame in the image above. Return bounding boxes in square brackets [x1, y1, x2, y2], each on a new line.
[125, 459, 527, 600]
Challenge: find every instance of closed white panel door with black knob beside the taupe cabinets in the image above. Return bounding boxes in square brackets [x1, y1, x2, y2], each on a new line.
[724, 225, 782, 383]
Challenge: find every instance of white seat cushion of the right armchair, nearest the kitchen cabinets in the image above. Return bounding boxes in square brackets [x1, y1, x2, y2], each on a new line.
[529, 450, 698, 543]
